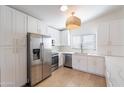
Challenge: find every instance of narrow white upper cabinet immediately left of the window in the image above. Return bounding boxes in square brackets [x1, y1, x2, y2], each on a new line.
[60, 30, 70, 46]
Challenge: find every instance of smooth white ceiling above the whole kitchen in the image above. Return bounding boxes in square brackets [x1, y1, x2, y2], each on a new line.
[10, 5, 121, 30]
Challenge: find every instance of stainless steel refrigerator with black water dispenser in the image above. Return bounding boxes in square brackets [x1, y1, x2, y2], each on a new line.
[27, 33, 52, 86]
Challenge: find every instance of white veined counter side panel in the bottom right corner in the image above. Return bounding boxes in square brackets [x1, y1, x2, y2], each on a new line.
[105, 56, 124, 87]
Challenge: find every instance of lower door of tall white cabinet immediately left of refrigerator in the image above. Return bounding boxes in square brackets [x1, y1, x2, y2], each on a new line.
[15, 47, 27, 87]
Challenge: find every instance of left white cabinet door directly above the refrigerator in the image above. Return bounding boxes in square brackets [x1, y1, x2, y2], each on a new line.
[28, 16, 38, 33]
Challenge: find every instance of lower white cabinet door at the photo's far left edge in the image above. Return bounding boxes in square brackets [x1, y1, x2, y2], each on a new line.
[0, 47, 15, 87]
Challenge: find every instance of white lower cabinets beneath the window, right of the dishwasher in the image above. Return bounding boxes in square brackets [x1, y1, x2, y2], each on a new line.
[72, 54, 105, 76]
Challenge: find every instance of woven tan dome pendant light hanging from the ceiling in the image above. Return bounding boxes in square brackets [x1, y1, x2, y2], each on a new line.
[66, 12, 81, 30]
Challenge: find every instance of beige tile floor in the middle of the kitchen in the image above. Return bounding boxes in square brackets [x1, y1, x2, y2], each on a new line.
[36, 67, 106, 87]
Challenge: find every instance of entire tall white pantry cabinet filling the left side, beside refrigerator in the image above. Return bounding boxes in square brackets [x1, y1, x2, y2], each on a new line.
[0, 6, 27, 87]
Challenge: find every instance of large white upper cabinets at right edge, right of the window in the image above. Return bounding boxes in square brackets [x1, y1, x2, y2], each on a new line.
[97, 19, 124, 56]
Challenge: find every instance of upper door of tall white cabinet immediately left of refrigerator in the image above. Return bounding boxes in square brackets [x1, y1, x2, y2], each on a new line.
[14, 11, 27, 47]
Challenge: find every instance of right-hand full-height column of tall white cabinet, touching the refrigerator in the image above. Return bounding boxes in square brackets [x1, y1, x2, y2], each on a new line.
[14, 11, 27, 86]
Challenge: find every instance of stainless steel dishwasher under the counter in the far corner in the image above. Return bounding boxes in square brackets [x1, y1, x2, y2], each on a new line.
[64, 54, 72, 68]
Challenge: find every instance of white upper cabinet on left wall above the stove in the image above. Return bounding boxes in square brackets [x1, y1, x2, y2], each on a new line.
[47, 27, 60, 46]
